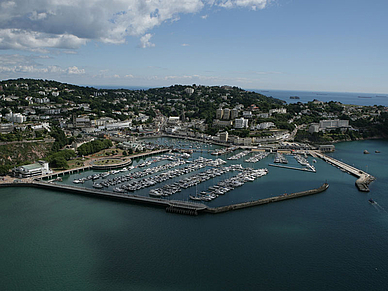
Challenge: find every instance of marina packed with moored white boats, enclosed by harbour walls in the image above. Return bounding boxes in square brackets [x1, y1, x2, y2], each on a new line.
[2, 138, 372, 215]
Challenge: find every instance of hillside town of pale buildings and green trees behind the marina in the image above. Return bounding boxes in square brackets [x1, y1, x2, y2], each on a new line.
[0, 79, 388, 174]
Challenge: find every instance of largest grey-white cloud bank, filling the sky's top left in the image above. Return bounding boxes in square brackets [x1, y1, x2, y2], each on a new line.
[0, 0, 270, 50]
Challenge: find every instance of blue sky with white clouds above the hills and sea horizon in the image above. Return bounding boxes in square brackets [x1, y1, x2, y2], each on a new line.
[0, 0, 388, 94]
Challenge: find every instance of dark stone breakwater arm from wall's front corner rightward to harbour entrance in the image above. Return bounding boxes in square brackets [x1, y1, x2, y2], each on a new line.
[205, 183, 329, 214]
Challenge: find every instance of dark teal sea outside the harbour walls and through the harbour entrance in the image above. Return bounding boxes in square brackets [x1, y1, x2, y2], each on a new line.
[0, 140, 388, 290]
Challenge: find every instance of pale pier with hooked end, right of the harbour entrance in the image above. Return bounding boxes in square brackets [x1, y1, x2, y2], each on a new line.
[309, 151, 376, 192]
